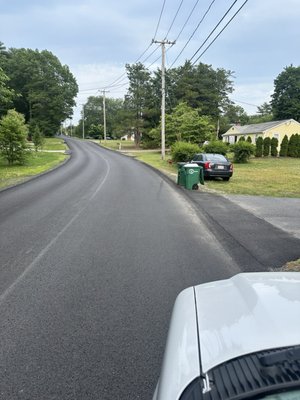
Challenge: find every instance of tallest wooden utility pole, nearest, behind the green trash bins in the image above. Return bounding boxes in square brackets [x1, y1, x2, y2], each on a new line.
[152, 39, 176, 160]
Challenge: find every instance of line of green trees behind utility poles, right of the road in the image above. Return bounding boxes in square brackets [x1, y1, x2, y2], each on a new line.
[75, 62, 300, 148]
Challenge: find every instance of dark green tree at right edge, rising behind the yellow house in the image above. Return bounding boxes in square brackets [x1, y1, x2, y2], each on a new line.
[271, 65, 300, 121]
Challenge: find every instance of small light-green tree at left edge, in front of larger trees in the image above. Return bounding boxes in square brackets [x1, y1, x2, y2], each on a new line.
[0, 110, 28, 165]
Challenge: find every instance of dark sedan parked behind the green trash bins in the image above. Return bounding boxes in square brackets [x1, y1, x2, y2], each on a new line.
[191, 153, 233, 181]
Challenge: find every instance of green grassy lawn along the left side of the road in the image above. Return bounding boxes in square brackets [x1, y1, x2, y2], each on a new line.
[0, 138, 68, 188]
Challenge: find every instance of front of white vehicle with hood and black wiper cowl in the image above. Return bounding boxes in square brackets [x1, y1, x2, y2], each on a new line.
[153, 272, 300, 400]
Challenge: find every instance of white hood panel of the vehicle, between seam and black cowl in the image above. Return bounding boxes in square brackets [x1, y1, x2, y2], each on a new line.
[195, 272, 300, 372]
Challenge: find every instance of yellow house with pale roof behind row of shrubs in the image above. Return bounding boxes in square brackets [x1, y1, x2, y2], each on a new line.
[222, 119, 300, 150]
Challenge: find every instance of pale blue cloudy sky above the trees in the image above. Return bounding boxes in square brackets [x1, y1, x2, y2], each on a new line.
[0, 0, 300, 124]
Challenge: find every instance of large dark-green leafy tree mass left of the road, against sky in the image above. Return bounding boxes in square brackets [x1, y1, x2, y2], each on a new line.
[0, 49, 78, 136]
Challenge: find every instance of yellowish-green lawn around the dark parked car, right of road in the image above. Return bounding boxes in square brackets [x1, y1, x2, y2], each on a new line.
[104, 145, 300, 197]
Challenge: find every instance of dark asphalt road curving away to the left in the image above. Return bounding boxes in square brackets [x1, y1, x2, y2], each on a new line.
[0, 140, 299, 400]
